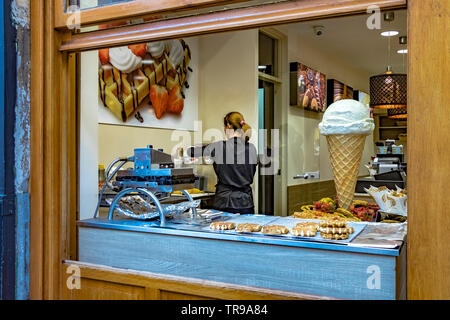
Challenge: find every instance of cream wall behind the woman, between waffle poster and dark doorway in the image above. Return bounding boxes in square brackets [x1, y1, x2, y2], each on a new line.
[195, 29, 258, 198]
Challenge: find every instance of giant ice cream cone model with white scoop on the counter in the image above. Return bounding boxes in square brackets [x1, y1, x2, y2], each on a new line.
[319, 99, 375, 210]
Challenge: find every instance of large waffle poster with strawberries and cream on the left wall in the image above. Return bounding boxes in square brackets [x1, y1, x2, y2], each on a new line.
[98, 39, 198, 130]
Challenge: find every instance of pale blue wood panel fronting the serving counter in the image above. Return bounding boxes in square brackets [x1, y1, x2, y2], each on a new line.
[79, 227, 396, 299]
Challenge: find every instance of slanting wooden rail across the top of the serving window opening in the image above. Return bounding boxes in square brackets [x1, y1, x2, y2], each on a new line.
[60, 0, 406, 52]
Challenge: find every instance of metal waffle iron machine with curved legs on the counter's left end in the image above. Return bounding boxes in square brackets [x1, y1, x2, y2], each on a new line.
[94, 146, 199, 227]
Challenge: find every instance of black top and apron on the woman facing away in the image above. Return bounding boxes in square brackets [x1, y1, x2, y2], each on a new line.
[204, 137, 258, 213]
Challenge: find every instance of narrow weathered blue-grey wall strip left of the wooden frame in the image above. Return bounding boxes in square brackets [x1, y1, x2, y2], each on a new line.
[10, 0, 31, 300]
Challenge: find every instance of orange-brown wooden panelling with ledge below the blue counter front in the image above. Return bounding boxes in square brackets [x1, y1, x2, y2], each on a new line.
[62, 261, 320, 300]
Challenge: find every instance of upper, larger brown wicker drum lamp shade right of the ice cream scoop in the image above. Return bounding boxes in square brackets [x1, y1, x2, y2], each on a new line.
[370, 73, 407, 109]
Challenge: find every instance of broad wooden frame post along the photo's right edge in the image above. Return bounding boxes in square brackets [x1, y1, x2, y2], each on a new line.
[407, 0, 450, 300]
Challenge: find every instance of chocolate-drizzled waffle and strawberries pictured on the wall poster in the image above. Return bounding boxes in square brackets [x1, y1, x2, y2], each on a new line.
[98, 39, 192, 123]
